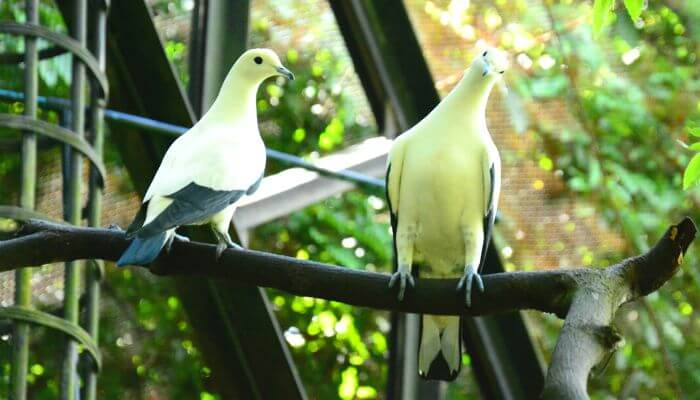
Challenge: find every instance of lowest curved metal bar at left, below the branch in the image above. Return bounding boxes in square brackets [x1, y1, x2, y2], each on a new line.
[0, 307, 102, 370]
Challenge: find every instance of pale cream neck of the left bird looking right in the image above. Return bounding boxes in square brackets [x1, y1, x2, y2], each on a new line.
[202, 69, 262, 128]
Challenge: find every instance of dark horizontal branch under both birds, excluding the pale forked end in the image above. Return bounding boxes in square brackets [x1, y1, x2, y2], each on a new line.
[0, 220, 576, 316]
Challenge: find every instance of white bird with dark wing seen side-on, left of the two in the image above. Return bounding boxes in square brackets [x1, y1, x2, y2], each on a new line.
[117, 49, 294, 266]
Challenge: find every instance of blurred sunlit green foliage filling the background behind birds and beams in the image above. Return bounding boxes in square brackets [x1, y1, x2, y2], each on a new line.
[0, 0, 700, 400]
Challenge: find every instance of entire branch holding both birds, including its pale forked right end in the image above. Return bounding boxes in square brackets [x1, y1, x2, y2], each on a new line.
[0, 218, 696, 399]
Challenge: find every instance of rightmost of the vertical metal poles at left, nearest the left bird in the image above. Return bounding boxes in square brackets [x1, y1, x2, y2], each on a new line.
[85, 1, 108, 400]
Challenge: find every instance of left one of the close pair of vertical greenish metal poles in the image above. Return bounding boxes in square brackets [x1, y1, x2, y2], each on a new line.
[61, 0, 87, 400]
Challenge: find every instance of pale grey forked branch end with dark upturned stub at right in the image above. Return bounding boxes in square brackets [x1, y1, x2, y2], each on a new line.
[543, 218, 697, 399]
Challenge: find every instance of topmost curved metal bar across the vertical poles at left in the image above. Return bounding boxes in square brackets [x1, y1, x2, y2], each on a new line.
[0, 22, 109, 99]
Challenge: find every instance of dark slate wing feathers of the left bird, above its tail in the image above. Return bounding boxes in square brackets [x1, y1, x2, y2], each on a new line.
[137, 182, 246, 237]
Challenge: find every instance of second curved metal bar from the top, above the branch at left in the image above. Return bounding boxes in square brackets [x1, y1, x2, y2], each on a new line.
[0, 113, 107, 187]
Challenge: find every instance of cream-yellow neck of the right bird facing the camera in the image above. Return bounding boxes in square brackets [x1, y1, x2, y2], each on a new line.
[435, 67, 496, 134]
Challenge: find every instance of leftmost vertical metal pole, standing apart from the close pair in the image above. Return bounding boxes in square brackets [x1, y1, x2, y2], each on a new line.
[10, 0, 39, 400]
